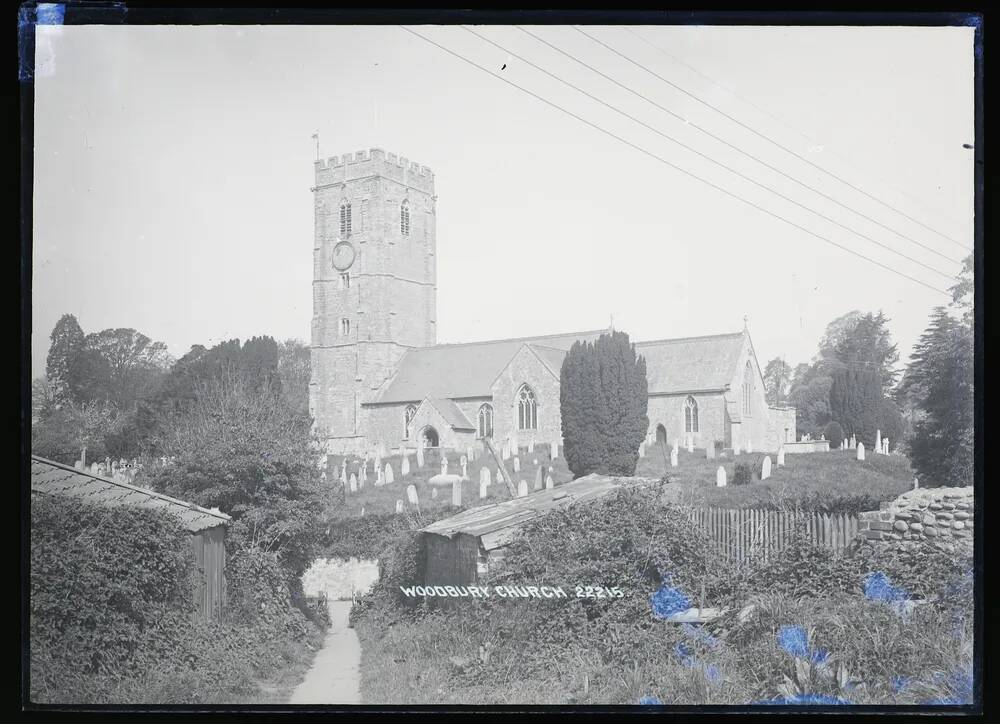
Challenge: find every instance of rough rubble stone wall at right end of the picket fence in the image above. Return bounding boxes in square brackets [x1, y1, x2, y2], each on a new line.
[858, 486, 974, 553]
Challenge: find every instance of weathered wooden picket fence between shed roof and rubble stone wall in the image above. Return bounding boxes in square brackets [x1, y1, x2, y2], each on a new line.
[688, 508, 858, 562]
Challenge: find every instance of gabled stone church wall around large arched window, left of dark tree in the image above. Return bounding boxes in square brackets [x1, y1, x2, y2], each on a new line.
[492, 347, 562, 446]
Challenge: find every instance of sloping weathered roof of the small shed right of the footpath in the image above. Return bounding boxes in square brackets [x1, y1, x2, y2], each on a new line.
[421, 474, 656, 551]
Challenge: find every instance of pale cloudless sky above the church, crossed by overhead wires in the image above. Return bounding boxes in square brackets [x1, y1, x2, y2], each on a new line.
[32, 26, 975, 375]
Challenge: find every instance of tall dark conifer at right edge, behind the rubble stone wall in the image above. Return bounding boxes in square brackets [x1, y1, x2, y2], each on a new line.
[902, 307, 975, 486]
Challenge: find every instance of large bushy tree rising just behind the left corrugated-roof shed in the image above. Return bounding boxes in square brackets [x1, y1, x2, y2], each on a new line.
[153, 365, 332, 590]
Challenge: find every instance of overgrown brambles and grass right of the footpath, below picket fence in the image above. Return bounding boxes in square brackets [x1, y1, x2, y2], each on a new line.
[355, 488, 972, 704]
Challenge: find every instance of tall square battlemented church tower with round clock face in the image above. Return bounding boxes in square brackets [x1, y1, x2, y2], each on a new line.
[309, 148, 437, 454]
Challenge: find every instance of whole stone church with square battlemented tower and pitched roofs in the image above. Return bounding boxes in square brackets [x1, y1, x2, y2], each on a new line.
[309, 149, 796, 454]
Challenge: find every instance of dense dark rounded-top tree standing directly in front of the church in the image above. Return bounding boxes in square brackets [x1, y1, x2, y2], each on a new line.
[559, 332, 649, 477]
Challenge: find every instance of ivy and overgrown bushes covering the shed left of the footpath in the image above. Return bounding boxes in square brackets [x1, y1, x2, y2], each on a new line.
[30, 496, 325, 704]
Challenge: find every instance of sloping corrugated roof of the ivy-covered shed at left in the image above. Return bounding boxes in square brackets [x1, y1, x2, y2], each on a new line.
[31, 455, 231, 533]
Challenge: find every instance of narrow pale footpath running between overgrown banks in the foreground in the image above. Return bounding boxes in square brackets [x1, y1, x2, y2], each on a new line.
[288, 601, 361, 704]
